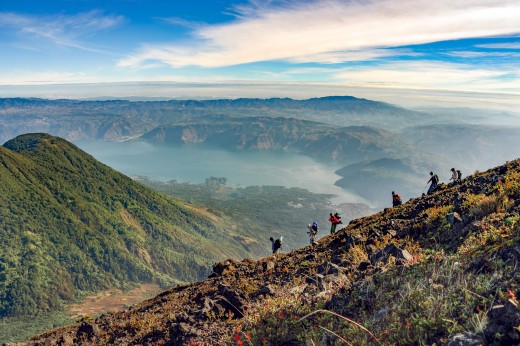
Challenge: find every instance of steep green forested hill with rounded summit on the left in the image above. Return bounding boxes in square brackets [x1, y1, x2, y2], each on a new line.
[0, 134, 254, 317]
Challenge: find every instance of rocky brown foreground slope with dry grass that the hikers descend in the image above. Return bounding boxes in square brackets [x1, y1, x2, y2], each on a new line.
[17, 160, 520, 345]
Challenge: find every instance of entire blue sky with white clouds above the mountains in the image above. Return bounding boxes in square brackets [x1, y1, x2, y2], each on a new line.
[0, 0, 520, 108]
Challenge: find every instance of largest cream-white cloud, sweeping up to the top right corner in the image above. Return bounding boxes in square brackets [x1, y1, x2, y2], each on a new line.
[118, 0, 520, 67]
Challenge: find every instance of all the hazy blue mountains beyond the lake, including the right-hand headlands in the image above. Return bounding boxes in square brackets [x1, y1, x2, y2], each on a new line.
[0, 96, 520, 206]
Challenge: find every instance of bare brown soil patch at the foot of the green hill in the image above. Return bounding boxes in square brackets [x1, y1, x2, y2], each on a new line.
[68, 284, 163, 319]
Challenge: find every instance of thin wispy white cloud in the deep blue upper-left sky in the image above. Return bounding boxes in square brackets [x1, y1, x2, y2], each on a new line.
[0, 11, 124, 51]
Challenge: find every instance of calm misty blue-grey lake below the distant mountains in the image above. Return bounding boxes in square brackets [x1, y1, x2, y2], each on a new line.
[75, 141, 362, 203]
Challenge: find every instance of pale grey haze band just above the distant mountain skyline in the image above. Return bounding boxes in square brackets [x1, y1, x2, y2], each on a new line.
[0, 82, 520, 114]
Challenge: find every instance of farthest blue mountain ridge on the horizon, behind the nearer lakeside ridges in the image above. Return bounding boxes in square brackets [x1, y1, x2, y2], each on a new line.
[0, 96, 430, 141]
